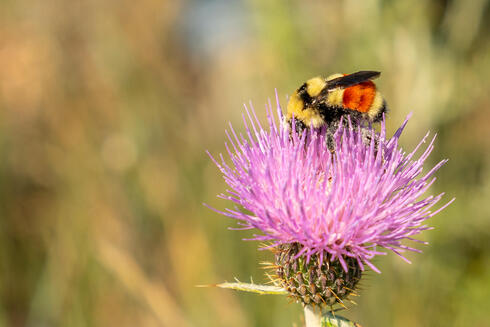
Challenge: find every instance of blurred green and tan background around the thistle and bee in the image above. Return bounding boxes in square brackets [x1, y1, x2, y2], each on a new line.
[0, 0, 490, 327]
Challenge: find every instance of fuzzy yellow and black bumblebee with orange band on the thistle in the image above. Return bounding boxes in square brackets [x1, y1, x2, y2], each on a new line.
[286, 71, 388, 132]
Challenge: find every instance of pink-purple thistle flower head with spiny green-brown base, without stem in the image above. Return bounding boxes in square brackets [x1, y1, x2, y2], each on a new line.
[207, 95, 450, 305]
